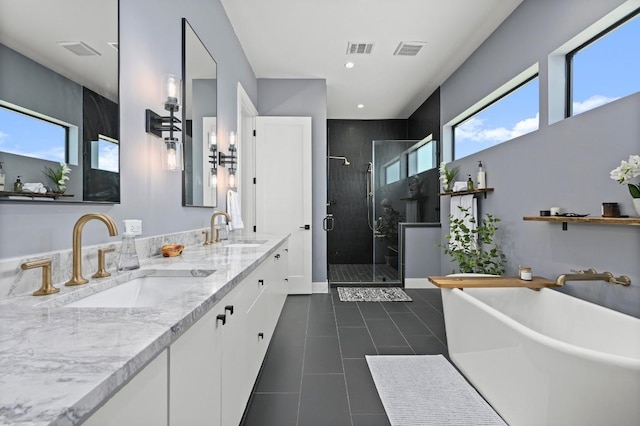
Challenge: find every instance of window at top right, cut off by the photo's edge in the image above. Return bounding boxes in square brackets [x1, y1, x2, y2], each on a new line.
[566, 12, 640, 117]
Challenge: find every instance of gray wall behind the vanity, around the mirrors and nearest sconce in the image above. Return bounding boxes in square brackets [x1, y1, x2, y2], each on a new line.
[0, 0, 258, 258]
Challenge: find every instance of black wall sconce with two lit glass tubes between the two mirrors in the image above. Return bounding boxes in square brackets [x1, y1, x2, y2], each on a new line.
[145, 74, 184, 171]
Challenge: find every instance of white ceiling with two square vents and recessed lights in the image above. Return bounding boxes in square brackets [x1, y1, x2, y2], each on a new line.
[221, 0, 522, 119]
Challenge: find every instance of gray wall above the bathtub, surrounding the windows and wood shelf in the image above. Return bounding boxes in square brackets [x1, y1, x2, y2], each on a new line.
[441, 0, 640, 316]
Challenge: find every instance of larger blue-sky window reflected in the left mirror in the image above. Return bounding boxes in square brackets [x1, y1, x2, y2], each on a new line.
[0, 105, 69, 163]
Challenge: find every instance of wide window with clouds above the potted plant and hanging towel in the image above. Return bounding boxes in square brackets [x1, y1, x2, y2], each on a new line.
[453, 74, 540, 159]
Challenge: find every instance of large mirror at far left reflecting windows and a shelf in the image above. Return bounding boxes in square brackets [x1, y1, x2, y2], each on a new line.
[0, 0, 120, 203]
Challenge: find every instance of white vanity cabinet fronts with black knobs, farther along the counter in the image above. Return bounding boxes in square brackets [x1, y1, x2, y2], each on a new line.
[169, 243, 287, 426]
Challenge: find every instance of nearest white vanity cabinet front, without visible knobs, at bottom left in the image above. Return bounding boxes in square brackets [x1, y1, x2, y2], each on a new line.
[83, 349, 168, 426]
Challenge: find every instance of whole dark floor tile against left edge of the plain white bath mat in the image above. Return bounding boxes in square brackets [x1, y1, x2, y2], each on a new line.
[344, 359, 384, 414]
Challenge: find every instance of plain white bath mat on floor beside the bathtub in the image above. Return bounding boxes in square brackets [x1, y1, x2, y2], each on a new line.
[366, 355, 506, 426]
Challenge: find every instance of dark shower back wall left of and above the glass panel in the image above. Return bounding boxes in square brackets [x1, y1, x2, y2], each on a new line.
[327, 120, 407, 264]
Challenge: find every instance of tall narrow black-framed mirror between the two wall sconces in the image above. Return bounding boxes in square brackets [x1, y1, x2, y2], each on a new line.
[182, 19, 218, 207]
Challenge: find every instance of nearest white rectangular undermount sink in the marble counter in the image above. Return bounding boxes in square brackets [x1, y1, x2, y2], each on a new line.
[63, 270, 215, 308]
